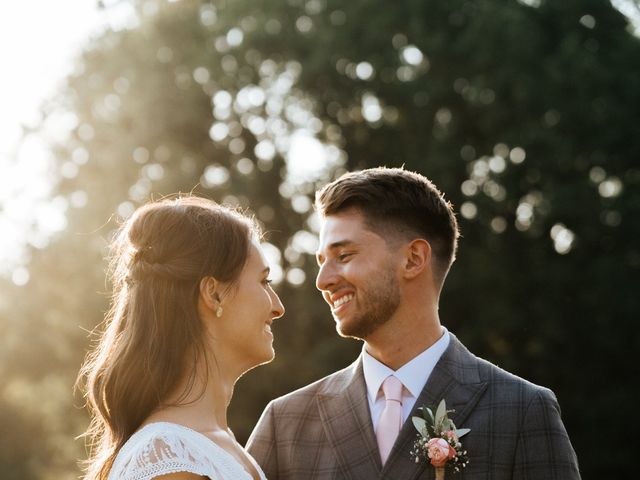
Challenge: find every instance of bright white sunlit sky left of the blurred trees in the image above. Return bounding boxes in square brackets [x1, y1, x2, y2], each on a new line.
[0, 0, 102, 278]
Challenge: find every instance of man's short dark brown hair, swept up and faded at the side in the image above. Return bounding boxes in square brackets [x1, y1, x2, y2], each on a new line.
[315, 167, 459, 283]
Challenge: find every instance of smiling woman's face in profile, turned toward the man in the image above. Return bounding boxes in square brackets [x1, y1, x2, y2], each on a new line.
[214, 241, 284, 371]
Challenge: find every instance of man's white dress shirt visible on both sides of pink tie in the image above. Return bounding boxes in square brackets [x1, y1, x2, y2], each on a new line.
[362, 327, 449, 432]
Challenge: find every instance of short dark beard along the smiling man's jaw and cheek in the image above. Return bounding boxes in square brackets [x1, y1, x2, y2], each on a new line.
[336, 266, 400, 340]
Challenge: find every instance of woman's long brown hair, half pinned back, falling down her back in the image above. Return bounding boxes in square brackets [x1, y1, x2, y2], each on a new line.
[78, 197, 257, 480]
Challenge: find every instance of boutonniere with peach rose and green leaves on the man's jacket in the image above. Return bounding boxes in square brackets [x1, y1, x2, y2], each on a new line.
[411, 399, 471, 480]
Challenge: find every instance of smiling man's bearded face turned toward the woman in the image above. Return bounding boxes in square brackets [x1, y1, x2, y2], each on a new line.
[316, 209, 400, 340]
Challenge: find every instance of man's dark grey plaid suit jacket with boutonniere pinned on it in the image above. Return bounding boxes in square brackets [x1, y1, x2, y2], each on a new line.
[247, 335, 580, 480]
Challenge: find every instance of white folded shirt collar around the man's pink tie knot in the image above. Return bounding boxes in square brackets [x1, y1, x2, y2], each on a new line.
[362, 327, 450, 402]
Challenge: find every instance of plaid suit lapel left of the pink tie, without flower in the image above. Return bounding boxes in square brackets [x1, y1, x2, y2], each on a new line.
[317, 358, 381, 479]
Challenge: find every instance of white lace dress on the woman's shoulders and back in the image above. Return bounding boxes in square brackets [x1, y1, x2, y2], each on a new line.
[109, 422, 266, 480]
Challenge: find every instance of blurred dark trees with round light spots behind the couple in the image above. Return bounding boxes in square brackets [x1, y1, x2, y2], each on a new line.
[0, 0, 640, 478]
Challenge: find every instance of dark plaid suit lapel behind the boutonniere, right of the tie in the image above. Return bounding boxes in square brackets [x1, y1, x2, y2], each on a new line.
[382, 334, 487, 479]
